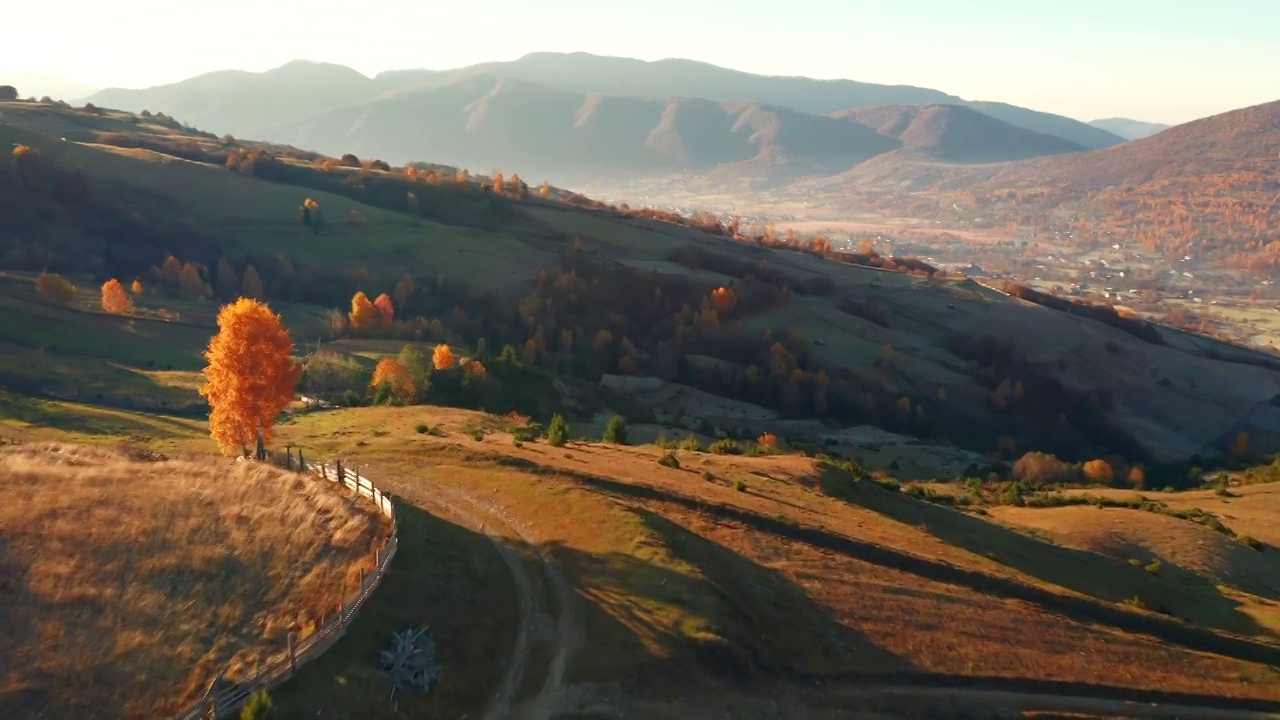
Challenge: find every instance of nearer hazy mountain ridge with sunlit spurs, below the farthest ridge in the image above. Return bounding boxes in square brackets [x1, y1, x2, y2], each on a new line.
[252, 74, 1084, 183]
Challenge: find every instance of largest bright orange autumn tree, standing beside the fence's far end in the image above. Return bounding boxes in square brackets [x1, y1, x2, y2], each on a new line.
[200, 297, 302, 460]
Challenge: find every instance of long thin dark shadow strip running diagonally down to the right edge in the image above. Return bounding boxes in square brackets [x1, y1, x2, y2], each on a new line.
[476, 455, 1280, 665]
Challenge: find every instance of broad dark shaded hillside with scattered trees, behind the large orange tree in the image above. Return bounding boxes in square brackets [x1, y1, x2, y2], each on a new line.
[0, 99, 1280, 477]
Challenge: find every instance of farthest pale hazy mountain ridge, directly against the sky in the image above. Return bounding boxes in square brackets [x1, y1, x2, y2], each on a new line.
[90, 53, 1124, 163]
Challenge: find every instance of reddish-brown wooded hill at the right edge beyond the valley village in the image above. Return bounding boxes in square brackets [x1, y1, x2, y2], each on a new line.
[808, 94, 1280, 263]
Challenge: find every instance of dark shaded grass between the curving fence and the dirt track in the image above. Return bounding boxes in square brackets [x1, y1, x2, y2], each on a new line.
[271, 498, 520, 720]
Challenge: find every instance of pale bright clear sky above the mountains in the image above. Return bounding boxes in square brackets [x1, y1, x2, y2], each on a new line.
[0, 0, 1280, 123]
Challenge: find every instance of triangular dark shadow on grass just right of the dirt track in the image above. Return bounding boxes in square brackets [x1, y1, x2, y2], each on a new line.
[549, 510, 915, 684]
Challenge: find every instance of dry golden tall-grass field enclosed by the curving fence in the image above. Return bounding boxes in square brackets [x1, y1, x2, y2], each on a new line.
[0, 443, 387, 717]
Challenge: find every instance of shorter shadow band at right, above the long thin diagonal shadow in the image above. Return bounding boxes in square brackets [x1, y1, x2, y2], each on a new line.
[819, 470, 1280, 635]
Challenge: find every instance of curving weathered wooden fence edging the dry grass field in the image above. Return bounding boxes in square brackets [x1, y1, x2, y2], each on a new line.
[177, 461, 399, 720]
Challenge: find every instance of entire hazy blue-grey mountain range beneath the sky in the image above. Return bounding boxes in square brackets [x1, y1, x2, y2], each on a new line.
[90, 53, 1125, 179]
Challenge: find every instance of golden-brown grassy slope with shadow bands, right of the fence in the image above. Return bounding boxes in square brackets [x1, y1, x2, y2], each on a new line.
[282, 407, 1280, 700]
